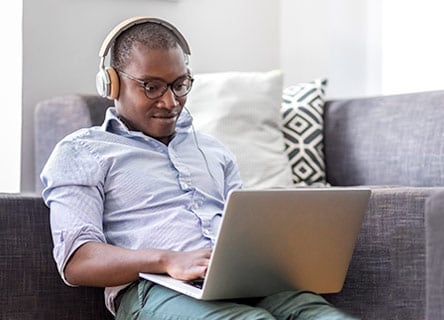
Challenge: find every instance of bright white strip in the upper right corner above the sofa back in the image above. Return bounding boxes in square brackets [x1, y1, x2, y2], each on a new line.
[381, 0, 444, 94]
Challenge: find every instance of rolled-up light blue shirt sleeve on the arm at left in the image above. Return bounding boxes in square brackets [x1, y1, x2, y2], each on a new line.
[40, 135, 106, 285]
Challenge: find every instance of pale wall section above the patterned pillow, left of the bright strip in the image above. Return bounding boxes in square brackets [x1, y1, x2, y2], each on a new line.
[280, 0, 382, 98]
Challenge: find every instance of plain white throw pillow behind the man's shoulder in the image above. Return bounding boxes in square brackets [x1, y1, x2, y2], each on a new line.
[187, 70, 293, 189]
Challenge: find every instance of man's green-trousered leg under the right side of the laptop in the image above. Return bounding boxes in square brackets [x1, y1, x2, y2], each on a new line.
[255, 291, 357, 320]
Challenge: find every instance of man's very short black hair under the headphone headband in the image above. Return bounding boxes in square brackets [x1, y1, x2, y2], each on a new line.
[111, 22, 180, 69]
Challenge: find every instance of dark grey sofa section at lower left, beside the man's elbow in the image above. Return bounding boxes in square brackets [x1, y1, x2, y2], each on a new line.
[0, 193, 113, 320]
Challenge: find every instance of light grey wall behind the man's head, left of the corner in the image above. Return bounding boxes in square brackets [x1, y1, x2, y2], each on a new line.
[21, 0, 280, 191]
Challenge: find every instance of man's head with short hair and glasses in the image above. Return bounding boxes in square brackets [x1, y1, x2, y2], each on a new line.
[97, 16, 192, 144]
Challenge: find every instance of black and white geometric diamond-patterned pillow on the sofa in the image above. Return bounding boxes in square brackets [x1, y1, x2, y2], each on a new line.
[281, 78, 328, 186]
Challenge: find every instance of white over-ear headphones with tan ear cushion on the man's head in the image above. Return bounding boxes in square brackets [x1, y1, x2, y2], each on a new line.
[96, 17, 191, 100]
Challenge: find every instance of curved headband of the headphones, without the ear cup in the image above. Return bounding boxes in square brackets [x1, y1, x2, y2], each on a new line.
[99, 17, 191, 58]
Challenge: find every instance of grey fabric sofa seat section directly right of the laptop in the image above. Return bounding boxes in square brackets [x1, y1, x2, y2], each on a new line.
[326, 187, 444, 319]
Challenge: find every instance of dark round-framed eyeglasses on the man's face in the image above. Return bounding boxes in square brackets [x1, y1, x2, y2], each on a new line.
[117, 70, 194, 99]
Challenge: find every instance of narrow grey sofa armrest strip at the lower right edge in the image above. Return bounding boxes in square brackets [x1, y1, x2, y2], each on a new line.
[425, 192, 444, 320]
